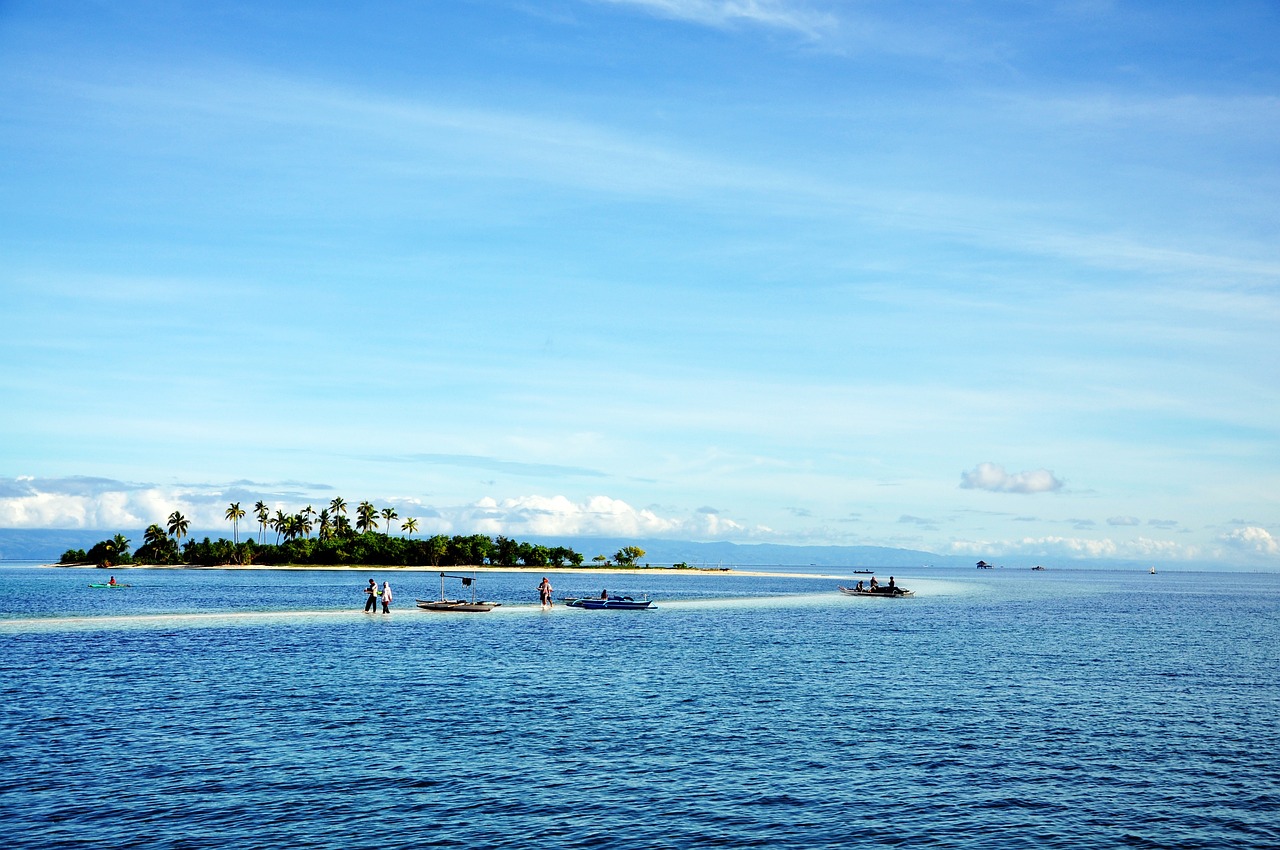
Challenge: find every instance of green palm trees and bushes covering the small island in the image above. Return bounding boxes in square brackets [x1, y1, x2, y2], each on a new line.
[61, 498, 644, 567]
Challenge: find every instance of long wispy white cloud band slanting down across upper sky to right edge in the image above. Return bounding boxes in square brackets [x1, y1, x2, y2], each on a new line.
[40, 64, 1280, 291]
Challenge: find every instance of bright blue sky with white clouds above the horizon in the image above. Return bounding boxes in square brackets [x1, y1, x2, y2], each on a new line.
[0, 0, 1280, 566]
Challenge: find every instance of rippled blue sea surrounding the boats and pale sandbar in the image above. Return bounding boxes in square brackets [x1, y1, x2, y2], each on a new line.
[0, 566, 1280, 849]
